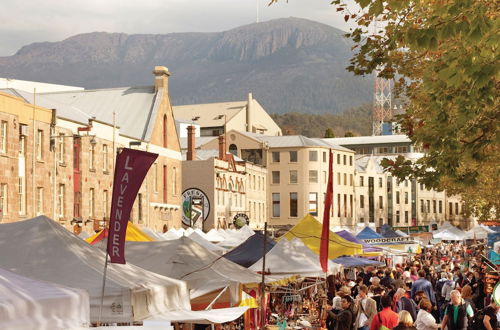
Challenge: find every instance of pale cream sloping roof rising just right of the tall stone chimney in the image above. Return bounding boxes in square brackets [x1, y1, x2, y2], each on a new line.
[172, 101, 247, 127]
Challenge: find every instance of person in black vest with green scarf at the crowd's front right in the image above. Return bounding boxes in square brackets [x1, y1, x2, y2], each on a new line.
[441, 290, 474, 330]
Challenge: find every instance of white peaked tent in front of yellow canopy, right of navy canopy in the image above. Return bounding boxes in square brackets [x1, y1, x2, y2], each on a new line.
[249, 238, 341, 276]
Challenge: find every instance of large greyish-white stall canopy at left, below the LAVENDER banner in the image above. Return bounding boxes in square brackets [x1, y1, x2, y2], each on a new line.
[0, 216, 190, 323]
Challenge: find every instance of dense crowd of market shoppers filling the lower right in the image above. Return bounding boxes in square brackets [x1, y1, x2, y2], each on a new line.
[325, 244, 500, 330]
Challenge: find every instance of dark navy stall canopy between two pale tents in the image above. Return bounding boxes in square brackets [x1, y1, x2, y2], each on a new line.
[223, 233, 276, 268]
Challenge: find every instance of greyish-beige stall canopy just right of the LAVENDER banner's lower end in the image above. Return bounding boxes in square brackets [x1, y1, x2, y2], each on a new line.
[125, 237, 276, 298]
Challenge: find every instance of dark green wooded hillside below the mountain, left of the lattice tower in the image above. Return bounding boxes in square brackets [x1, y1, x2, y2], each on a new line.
[271, 104, 372, 138]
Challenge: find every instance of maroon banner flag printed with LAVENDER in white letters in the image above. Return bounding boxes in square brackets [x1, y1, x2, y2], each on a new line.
[107, 148, 158, 264]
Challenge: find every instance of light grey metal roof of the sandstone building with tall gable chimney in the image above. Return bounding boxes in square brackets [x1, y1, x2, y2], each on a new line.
[1, 86, 158, 141]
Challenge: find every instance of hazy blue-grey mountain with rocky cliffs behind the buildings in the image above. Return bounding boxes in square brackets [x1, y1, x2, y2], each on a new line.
[0, 18, 372, 113]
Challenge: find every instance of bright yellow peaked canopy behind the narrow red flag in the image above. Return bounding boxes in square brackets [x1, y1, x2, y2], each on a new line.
[280, 214, 363, 259]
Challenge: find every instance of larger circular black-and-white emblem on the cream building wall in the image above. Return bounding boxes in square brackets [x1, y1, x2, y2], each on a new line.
[182, 188, 210, 229]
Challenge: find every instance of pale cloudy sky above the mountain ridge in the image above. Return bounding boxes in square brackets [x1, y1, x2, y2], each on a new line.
[0, 0, 360, 56]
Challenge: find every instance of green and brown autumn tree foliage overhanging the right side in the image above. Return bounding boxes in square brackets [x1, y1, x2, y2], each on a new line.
[332, 0, 500, 218]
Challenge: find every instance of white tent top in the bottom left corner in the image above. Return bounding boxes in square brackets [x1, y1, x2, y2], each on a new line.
[0, 268, 90, 330]
